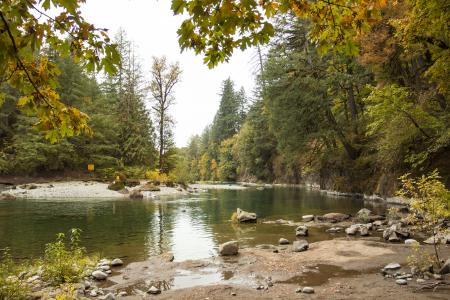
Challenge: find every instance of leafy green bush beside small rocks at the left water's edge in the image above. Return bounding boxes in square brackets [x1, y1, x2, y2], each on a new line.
[42, 229, 94, 284]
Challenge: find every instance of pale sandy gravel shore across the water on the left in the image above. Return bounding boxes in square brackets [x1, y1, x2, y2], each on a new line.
[1, 181, 187, 199]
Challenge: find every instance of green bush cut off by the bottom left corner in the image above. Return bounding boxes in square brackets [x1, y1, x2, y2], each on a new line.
[0, 249, 28, 300]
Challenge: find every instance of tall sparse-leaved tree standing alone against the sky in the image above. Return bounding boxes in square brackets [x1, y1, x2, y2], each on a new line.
[150, 56, 181, 173]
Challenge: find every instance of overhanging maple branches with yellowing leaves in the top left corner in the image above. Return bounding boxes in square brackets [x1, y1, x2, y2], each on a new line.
[0, 0, 120, 142]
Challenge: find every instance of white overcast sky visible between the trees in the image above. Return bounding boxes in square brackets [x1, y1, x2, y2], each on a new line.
[82, 0, 255, 147]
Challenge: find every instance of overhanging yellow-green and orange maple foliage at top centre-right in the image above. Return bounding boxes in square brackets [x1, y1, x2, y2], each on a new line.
[172, 0, 387, 67]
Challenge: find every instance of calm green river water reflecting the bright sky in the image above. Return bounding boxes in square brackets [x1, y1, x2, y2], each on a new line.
[0, 188, 382, 262]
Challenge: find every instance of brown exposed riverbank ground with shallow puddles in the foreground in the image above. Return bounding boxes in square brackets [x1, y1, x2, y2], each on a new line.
[98, 238, 450, 300]
